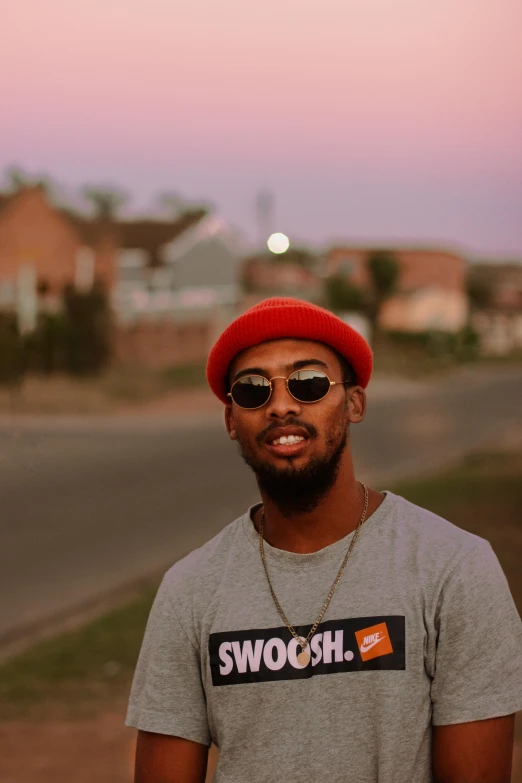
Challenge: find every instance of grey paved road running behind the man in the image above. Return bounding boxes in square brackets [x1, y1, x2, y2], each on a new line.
[0, 369, 522, 646]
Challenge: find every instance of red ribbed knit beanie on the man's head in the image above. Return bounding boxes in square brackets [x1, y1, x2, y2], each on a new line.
[207, 297, 373, 404]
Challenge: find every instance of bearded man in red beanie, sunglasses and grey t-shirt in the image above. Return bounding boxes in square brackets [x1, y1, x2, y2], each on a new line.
[127, 299, 522, 783]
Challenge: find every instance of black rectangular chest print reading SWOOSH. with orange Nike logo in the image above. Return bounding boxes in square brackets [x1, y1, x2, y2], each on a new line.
[209, 615, 406, 685]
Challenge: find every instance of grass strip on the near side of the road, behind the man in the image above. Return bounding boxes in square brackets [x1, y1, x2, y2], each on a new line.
[0, 451, 522, 720]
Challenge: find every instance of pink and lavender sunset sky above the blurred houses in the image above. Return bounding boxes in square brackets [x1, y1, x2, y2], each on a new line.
[0, 0, 522, 258]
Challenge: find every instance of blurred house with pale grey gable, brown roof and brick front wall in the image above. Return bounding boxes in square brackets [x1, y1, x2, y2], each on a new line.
[113, 211, 244, 367]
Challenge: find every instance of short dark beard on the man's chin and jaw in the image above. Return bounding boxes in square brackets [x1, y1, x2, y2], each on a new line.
[238, 422, 348, 517]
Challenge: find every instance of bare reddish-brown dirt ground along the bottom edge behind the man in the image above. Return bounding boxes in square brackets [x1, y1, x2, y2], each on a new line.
[0, 705, 522, 783]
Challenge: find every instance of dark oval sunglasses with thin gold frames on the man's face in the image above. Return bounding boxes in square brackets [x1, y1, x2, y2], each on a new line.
[227, 370, 351, 410]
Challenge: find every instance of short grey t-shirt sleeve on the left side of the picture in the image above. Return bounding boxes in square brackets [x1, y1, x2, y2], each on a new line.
[125, 580, 211, 746]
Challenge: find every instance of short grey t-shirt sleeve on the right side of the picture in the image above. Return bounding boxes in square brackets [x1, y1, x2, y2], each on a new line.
[431, 540, 522, 726]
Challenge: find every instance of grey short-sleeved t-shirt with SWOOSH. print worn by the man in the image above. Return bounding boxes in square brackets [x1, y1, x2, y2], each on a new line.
[126, 492, 522, 783]
